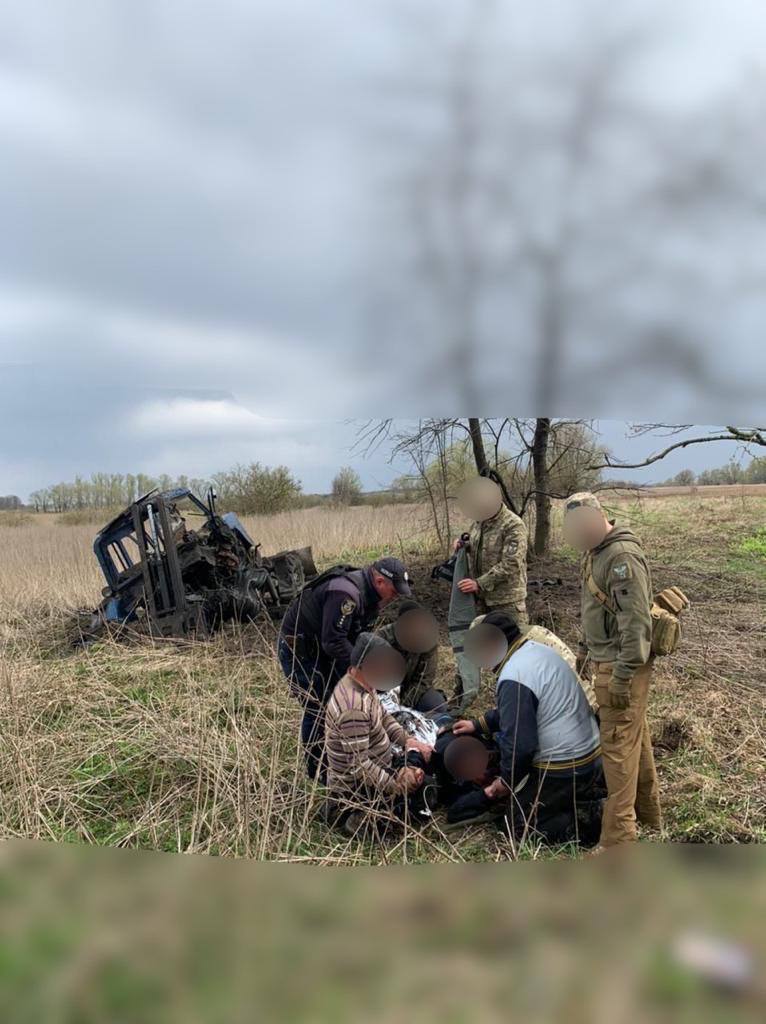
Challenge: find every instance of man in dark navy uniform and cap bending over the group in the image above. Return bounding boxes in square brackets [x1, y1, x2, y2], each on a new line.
[276, 556, 412, 782]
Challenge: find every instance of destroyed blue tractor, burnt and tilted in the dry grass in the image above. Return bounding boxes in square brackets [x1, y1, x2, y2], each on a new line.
[80, 487, 316, 641]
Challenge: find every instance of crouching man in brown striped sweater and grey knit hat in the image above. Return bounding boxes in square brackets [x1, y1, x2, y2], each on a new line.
[325, 633, 432, 836]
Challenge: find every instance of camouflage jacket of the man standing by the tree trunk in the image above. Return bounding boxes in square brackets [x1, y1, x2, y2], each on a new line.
[468, 505, 526, 608]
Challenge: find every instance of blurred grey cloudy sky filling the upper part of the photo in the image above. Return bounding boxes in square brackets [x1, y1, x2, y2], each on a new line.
[0, 0, 766, 436]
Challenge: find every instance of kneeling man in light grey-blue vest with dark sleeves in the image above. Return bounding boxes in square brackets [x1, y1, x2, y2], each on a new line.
[454, 612, 606, 845]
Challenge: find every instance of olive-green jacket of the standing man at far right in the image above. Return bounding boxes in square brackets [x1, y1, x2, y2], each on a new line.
[581, 526, 652, 679]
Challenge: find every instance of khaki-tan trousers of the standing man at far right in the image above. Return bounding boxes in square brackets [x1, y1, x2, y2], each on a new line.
[594, 662, 662, 846]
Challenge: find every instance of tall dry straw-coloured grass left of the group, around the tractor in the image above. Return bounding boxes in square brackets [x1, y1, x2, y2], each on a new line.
[0, 506, 500, 863]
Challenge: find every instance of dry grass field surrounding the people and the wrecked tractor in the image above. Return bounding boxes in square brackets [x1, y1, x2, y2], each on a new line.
[0, 494, 766, 864]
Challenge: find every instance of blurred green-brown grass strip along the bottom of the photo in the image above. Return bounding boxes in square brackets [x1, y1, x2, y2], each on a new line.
[0, 842, 766, 1024]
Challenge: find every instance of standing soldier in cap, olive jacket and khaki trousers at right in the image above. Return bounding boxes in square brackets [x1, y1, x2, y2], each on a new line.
[564, 492, 662, 847]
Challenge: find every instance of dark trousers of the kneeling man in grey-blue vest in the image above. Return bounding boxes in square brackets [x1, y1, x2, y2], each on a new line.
[506, 758, 606, 846]
